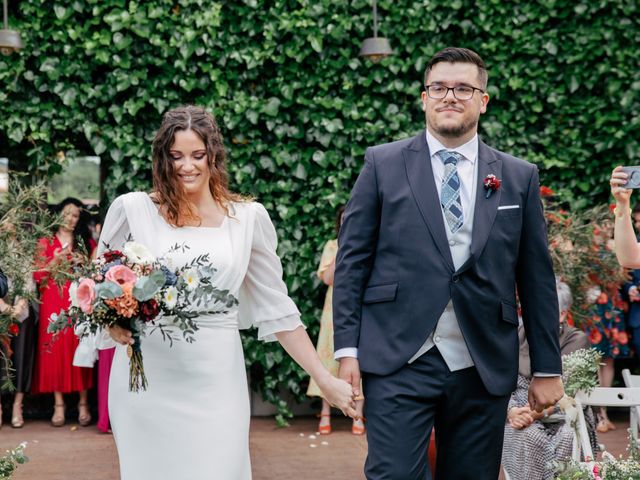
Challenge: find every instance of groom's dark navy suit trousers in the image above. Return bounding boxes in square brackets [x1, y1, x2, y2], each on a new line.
[363, 347, 509, 480]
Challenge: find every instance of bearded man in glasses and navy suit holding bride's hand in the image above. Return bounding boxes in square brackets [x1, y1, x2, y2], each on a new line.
[333, 48, 563, 480]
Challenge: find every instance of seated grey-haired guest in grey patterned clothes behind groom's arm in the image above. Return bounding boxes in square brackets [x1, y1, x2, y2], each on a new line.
[502, 282, 597, 480]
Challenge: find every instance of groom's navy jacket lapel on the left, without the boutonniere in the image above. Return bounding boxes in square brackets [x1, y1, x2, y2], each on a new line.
[402, 130, 455, 271]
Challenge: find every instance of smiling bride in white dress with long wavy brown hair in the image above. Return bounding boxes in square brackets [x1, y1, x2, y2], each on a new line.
[99, 107, 356, 480]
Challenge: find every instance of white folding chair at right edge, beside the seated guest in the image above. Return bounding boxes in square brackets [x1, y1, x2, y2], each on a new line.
[572, 387, 640, 462]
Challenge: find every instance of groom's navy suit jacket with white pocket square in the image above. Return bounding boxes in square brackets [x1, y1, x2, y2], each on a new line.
[333, 131, 562, 395]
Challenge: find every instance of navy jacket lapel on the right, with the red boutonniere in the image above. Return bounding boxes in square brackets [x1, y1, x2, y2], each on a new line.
[468, 142, 502, 270]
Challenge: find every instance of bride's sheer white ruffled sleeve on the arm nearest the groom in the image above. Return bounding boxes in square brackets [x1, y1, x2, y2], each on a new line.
[239, 203, 302, 341]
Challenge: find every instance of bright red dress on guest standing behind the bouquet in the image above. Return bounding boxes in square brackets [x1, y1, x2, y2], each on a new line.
[32, 235, 95, 393]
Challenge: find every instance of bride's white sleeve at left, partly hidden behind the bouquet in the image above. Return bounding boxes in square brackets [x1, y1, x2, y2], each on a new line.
[92, 196, 131, 348]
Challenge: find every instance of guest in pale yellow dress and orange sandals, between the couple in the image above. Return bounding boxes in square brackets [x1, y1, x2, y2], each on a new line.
[307, 206, 365, 435]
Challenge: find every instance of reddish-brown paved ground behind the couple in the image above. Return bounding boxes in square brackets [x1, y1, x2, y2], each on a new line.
[0, 413, 629, 480]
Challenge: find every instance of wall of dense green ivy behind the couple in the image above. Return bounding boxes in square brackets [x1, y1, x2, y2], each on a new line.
[0, 0, 640, 421]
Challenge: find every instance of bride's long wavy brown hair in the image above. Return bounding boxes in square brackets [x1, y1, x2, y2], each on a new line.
[152, 105, 246, 227]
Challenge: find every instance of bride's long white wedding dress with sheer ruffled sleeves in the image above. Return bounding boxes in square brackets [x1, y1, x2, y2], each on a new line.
[99, 192, 302, 480]
